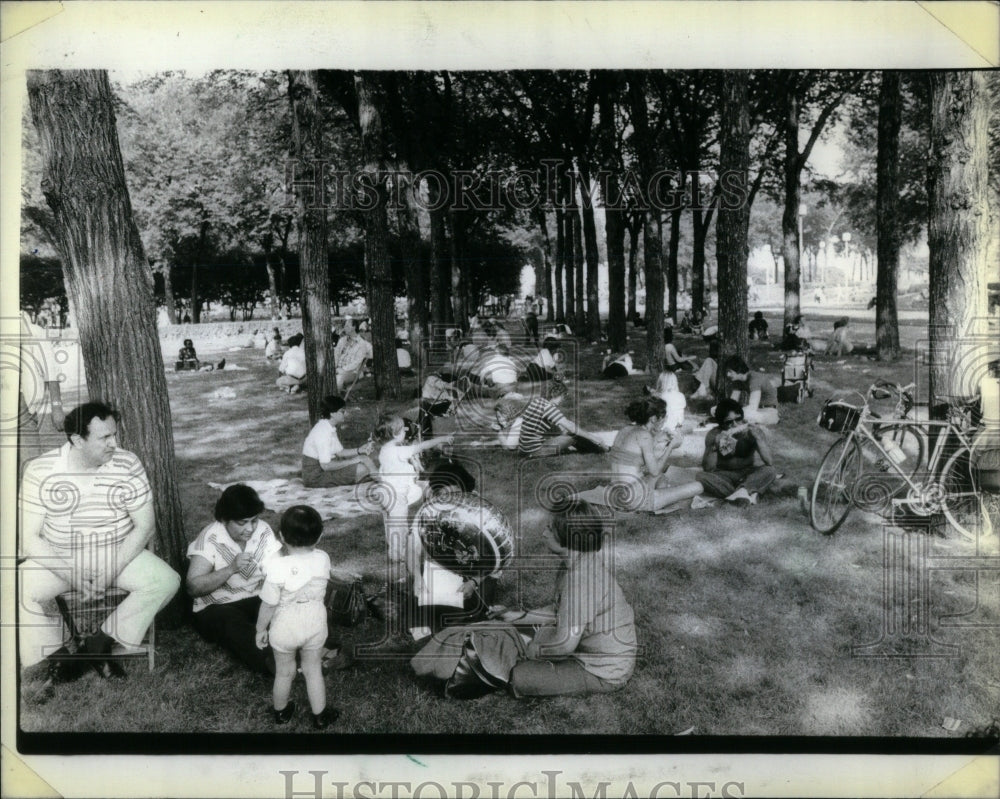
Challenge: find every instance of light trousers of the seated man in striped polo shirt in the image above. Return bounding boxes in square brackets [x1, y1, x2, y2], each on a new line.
[17, 550, 181, 668]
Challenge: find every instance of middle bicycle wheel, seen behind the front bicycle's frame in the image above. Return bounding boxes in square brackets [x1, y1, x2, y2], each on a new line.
[851, 422, 925, 516]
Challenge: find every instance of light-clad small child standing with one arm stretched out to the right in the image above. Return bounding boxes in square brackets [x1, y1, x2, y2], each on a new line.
[375, 416, 455, 582]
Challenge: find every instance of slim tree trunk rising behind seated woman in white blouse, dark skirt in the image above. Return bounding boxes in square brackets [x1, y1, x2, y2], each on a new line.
[288, 70, 337, 424]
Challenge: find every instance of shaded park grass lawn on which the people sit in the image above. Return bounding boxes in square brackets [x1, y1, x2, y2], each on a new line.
[20, 320, 1000, 736]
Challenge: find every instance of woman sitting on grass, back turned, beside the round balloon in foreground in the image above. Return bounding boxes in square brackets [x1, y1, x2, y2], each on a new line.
[502, 500, 637, 697]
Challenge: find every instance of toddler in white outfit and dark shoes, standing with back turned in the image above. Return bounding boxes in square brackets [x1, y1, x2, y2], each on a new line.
[257, 505, 340, 730]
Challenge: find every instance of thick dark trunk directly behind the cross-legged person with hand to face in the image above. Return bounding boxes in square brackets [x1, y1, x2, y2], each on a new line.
[715, 70, 750, 397]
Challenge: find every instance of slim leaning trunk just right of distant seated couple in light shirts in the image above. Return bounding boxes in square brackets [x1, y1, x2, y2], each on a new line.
[354, 72, 400, 399]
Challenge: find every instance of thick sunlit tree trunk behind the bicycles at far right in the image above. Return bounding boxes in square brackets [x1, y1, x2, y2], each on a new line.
[927, 71, 997, 402]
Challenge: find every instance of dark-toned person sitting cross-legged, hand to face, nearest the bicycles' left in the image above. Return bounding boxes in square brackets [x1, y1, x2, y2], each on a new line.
[695, 399, 778, 505]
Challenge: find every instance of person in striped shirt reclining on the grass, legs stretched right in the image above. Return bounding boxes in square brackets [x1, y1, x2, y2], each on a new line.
[497, 380, 608, 458]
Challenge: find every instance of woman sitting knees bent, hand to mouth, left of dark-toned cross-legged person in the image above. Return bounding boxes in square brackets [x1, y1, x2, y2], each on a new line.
[608, 396, 704, 511]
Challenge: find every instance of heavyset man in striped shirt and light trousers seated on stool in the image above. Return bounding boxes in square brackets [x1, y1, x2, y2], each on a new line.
[18, 402, 180, 681]
